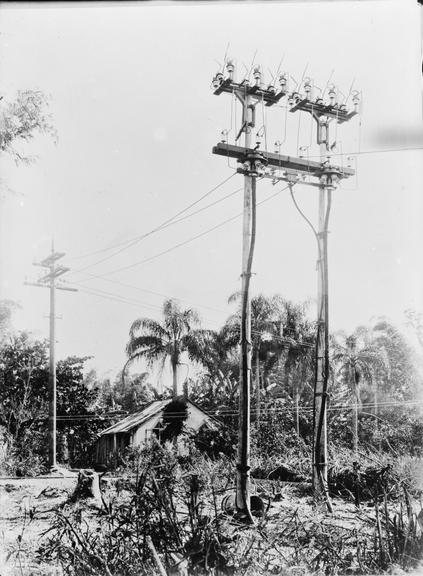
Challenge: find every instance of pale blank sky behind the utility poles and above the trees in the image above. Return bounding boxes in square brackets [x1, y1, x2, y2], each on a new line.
[0, 0, 423, 384]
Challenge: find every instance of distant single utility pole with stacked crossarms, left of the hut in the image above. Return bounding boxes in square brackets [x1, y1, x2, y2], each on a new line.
[25, 243, 77, 472]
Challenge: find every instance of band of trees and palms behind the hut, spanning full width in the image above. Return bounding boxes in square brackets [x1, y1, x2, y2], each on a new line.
[0, 294, 423, 468]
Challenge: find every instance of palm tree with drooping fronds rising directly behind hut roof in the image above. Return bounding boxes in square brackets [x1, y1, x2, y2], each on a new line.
[126, 299, 200, 398]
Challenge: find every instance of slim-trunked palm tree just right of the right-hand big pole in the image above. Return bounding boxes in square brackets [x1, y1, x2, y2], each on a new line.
[332, 326, 387, 454]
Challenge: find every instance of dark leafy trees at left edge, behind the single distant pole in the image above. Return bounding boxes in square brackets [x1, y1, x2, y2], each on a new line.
[0, 332, 104, 472]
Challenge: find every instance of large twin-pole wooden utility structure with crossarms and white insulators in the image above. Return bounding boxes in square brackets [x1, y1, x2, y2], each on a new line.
[213, 61, 358, 520]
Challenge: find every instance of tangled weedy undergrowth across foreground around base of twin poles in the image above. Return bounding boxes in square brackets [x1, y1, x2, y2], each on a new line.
[32, 443, 423, 576]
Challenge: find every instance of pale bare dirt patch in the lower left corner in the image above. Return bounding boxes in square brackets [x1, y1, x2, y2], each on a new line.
[0, 472, 77, 576]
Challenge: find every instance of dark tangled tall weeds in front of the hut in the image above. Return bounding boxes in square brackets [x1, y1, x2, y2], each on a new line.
[40, 442, 238, 576]
